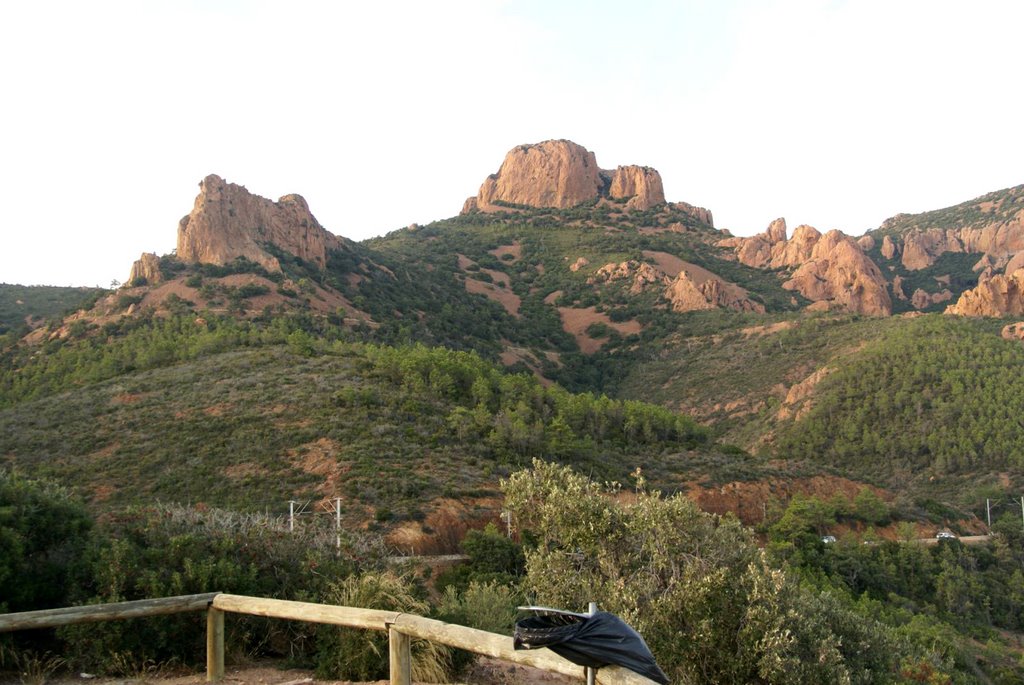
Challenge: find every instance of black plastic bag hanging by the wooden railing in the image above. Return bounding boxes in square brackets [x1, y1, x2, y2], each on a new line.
[512, 611, 669, 685]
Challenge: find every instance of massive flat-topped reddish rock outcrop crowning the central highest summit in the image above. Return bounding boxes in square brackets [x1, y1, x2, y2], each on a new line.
[462, 140, 665, 214]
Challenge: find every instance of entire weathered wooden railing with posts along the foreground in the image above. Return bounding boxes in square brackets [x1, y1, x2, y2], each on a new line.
[0, 593, 653, 685]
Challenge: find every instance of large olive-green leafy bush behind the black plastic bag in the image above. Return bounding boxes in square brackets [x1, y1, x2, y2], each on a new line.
[504, 462, 999, 684]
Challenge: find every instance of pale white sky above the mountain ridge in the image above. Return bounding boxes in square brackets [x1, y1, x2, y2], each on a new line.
[0, 0, 1024, 287]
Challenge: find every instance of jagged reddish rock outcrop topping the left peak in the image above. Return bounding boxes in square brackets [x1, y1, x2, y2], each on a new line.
[177, 174, 344, 271]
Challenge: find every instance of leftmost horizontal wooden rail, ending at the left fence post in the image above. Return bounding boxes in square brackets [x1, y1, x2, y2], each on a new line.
[0, 592, 218, 633]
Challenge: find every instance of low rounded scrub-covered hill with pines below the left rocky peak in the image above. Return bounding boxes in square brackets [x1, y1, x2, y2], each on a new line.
[0, 339, 707, 522]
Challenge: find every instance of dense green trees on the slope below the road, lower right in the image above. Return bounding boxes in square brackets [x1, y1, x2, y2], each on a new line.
[768, 490, 1024, 683]
